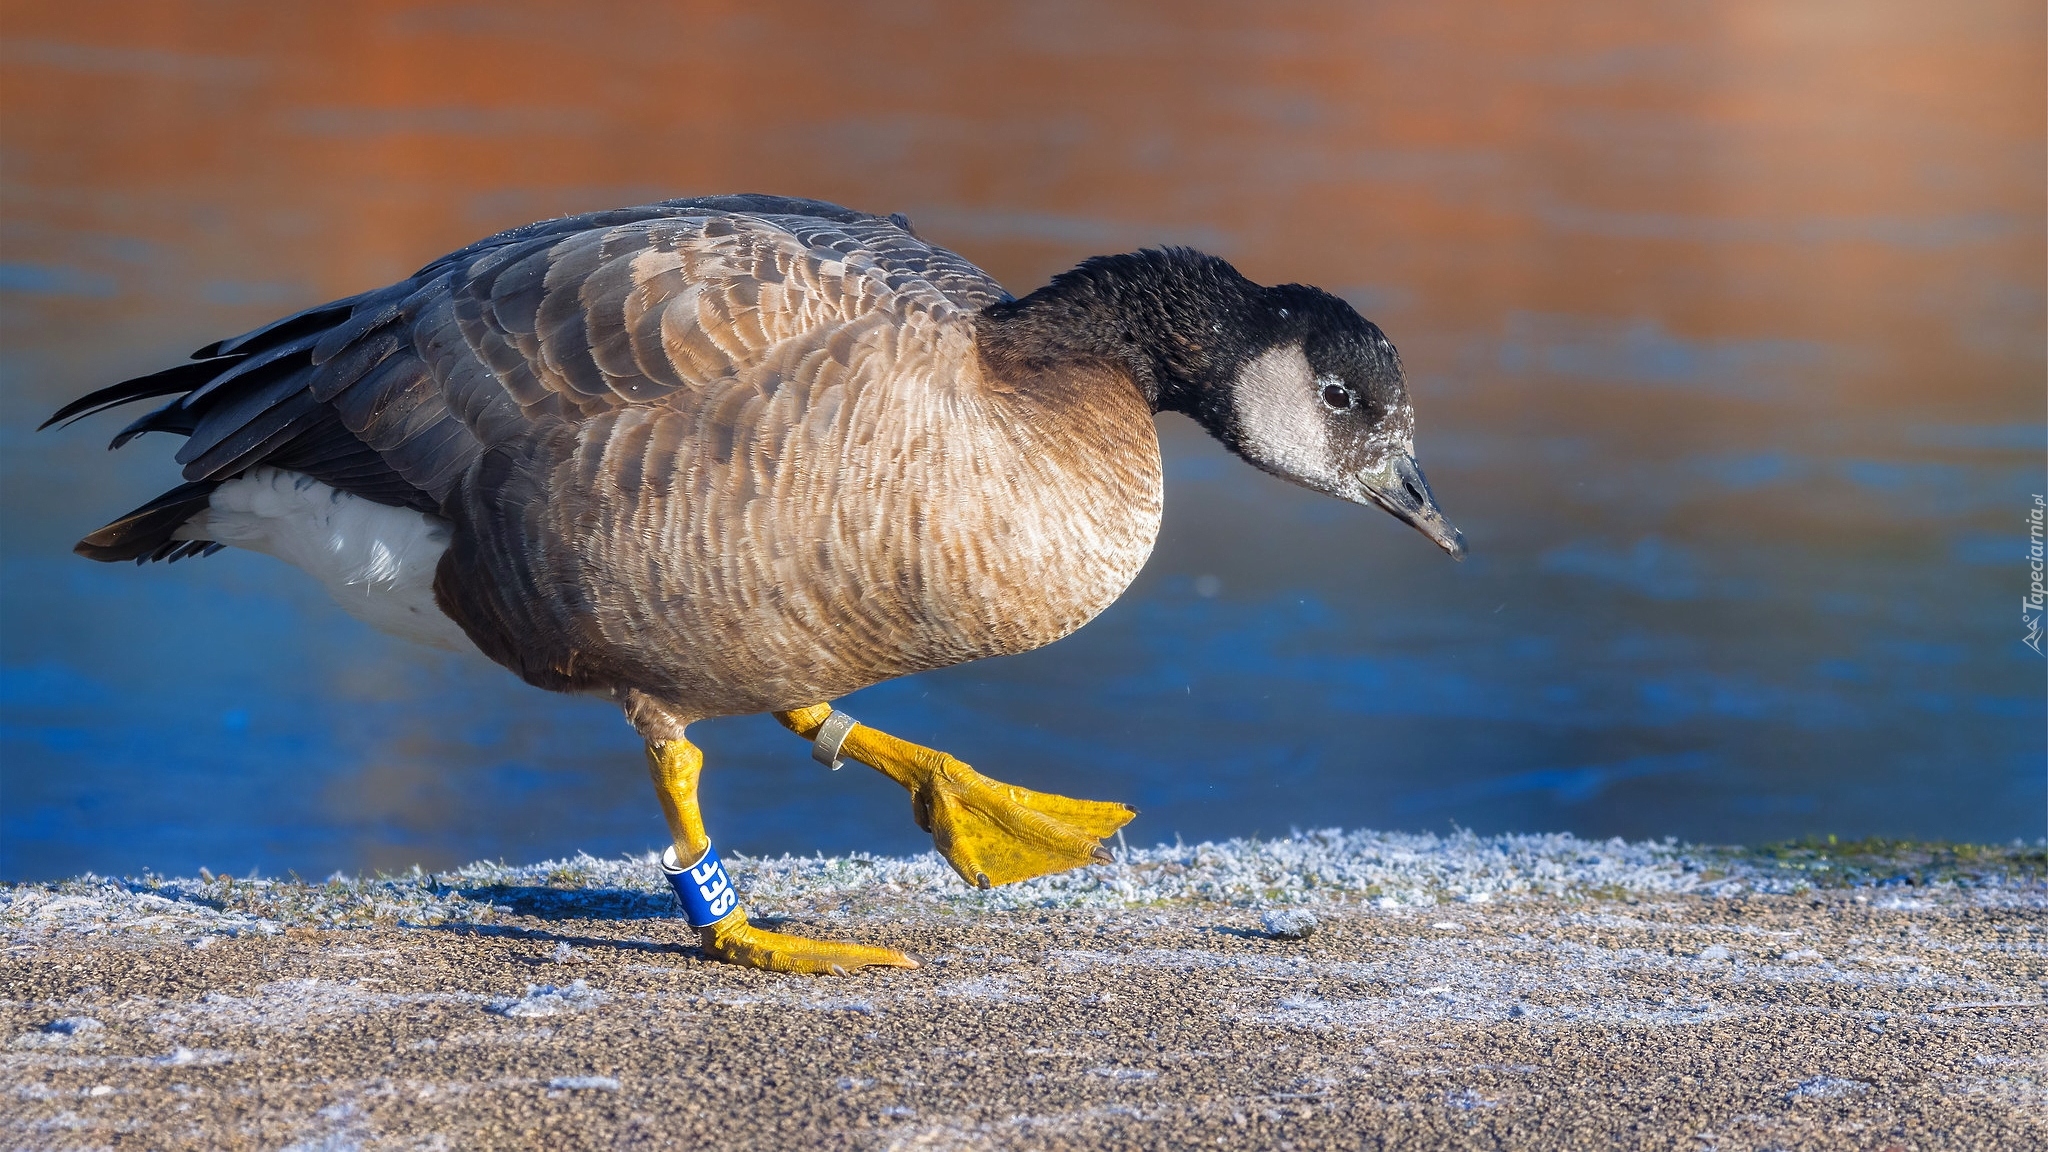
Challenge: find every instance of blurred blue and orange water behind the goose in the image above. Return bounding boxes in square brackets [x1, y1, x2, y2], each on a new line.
[0, 0, 2048, 879]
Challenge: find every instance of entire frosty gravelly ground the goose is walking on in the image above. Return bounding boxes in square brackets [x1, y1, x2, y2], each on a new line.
[0, 832, 2048, 1150]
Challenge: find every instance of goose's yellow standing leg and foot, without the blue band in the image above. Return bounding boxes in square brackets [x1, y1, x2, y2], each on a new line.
[647, 736, 918, 976]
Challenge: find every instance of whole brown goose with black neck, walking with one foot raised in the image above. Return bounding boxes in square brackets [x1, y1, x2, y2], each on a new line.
[45, 195, 1464, 974]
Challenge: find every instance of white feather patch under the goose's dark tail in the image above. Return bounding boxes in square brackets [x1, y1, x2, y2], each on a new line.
[176, 467, 475, 652]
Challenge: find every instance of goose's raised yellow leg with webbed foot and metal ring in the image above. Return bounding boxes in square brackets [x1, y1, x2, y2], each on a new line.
[774, 703, 1137, 888]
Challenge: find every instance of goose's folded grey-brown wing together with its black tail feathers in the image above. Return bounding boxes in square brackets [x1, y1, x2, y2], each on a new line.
[45, 195, 1008, 560]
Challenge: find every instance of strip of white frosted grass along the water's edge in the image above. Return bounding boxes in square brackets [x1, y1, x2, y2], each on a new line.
[0, 830, 2048, 945]
